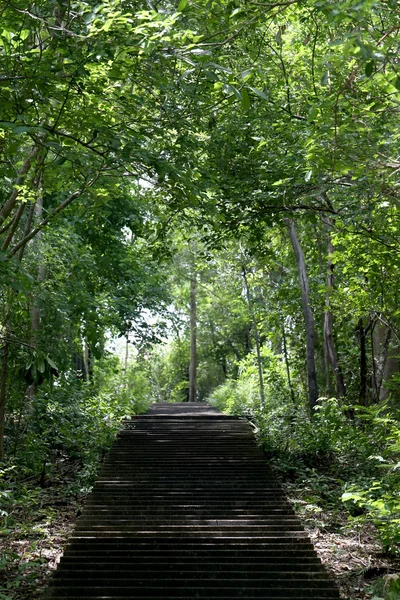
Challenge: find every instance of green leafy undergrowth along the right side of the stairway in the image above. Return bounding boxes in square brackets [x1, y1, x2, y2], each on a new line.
[209, 352, 400, 600]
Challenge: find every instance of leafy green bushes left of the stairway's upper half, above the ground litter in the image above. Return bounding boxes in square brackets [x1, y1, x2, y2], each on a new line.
[8, 356, 150, 487]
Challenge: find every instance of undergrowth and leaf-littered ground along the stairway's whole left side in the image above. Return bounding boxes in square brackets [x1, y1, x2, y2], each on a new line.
[0, 357, 150, 600]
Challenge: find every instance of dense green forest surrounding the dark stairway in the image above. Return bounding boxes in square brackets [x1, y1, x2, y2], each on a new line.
[0, 0, 400, 600]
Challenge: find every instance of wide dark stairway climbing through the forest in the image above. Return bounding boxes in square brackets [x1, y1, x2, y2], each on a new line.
[46, 403, 339, 600]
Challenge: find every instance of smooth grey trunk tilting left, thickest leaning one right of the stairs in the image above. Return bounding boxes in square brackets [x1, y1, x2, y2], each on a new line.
[285, 219, 318, 414]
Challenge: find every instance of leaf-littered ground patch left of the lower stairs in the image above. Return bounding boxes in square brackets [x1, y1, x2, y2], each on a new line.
[0, 463, 84, 600]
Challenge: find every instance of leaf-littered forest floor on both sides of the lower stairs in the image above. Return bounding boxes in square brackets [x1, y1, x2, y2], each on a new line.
[0, 465, 400, 600]
